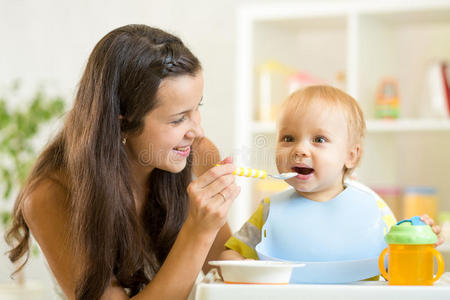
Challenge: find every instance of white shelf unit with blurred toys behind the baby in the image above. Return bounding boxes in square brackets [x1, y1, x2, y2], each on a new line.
[230, 0, 450, 228]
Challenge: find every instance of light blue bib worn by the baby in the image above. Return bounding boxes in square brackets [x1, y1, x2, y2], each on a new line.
[256, 185, 387, 282]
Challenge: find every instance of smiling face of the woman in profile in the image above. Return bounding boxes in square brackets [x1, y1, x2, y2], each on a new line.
[126, 72, 203, 173]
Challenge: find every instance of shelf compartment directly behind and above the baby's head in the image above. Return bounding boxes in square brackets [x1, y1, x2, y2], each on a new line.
[251, 15, 348, 121]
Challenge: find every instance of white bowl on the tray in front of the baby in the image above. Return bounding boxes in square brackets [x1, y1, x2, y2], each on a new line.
[209, 260, 304, 284]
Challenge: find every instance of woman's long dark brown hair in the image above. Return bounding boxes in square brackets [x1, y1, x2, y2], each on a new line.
[6, 25, 201, 299]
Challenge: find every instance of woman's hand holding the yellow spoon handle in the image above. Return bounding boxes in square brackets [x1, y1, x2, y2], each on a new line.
[186, 157, 241, 238]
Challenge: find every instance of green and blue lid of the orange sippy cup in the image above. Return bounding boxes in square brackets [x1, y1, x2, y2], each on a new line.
[384, 216, 437, 245]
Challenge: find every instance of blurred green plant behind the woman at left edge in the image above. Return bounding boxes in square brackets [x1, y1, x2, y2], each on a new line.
[0, 81, 65, 282]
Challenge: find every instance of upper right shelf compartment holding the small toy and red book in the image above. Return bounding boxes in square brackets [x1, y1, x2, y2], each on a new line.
[355, 6, 450, 118]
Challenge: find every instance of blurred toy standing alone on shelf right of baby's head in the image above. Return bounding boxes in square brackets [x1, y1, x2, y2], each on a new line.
[375, 78, 399, 119]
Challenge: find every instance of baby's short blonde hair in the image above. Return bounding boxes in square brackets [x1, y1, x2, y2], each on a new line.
[282, 85, 366, 178]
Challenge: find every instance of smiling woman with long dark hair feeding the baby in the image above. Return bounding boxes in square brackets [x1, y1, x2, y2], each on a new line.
[7, 25, 240, 299]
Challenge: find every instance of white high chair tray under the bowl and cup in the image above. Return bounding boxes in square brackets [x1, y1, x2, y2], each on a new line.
[195, 272, 450, 300]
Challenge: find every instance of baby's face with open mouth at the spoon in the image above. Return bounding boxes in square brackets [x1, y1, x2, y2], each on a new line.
[276, 102, 358, 201]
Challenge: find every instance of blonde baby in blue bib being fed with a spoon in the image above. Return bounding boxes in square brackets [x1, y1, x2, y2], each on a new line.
[221, 85, 439, 279]
